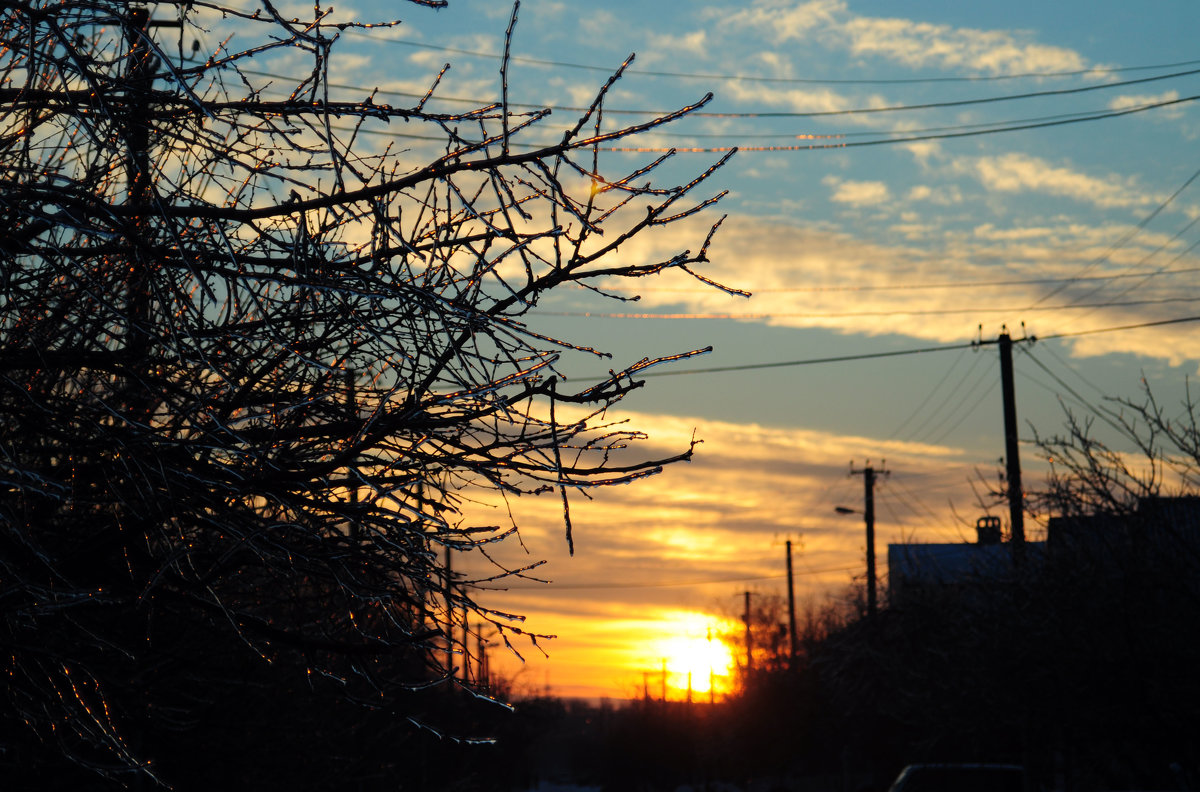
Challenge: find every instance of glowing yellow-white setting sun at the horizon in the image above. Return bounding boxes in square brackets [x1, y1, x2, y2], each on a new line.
[656, 612, 733, 697]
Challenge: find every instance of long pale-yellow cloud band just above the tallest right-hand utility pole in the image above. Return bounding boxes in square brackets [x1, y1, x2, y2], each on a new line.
[576, 207, 1194, 360]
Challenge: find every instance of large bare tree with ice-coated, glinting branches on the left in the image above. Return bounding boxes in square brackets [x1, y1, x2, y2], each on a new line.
[0, 0, 725, 774]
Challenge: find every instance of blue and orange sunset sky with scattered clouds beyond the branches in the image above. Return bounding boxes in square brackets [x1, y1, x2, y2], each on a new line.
[223, 0, 1200, 697]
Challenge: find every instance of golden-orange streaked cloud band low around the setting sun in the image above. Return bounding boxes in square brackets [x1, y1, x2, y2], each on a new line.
[456, 413, 970, 696]
